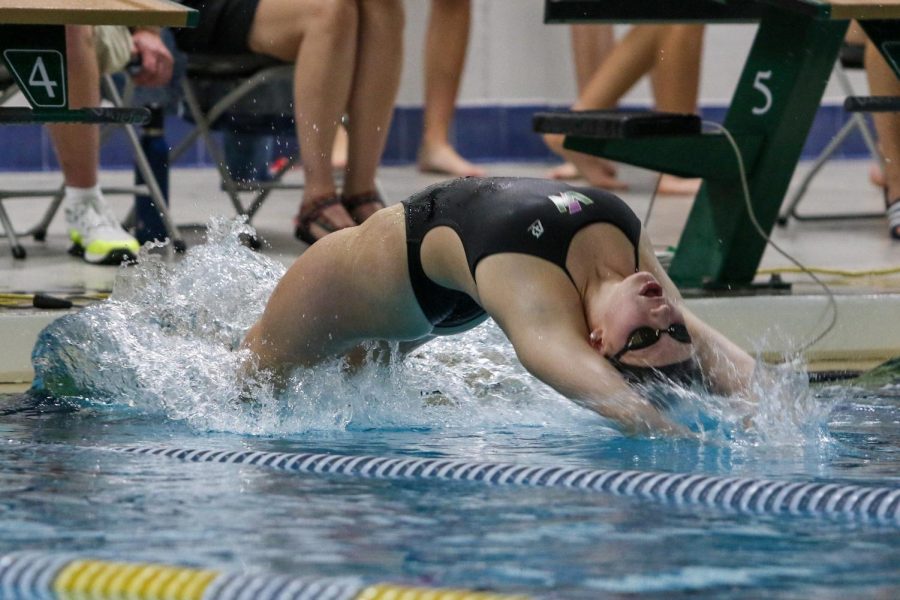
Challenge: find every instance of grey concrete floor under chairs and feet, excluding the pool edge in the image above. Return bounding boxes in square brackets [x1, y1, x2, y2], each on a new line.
[0, 160, 900, 293]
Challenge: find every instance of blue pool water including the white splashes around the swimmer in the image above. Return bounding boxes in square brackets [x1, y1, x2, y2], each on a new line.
[0, 222, 900, 599]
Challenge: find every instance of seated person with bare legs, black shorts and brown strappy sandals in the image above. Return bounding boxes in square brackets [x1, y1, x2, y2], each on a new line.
[175, 0, 404, 244]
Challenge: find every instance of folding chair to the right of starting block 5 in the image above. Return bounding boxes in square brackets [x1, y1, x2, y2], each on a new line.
[777, 44, 884, 226]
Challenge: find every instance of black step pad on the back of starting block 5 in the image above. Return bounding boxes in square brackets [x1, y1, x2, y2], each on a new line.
[532, 110, 701, 139]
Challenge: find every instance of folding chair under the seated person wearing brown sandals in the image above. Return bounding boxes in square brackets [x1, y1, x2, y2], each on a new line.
[170, 54, 303, 234]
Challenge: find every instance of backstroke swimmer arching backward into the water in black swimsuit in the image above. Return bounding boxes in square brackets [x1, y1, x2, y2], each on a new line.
[242, 178, 755, 433]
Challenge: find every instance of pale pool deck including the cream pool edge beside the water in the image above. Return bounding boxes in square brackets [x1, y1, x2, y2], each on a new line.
[0, 160, 900, 392]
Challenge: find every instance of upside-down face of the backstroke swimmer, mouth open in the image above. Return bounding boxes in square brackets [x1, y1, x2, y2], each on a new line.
[590, 272, 692, 367]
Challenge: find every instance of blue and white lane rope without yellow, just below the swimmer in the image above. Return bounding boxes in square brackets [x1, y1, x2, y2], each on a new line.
[108, 446, 900, 525]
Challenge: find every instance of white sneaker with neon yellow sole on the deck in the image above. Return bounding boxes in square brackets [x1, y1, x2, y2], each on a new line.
[63, 196, 141, 265]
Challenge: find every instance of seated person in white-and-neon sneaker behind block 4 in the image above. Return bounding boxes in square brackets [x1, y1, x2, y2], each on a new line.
[47, 25, 174, 265]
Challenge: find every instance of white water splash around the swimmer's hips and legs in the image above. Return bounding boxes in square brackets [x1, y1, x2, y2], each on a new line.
[32, 219, 597, 435]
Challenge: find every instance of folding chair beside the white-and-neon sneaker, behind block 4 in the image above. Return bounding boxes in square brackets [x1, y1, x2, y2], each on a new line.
[0, 68, 185, 259]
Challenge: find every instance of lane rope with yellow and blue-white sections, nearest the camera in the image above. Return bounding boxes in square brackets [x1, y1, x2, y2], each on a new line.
[0, 552, 527, 600]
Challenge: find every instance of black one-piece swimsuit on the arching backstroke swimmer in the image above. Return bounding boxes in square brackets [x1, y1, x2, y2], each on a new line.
[403, 178, 641, 334]
